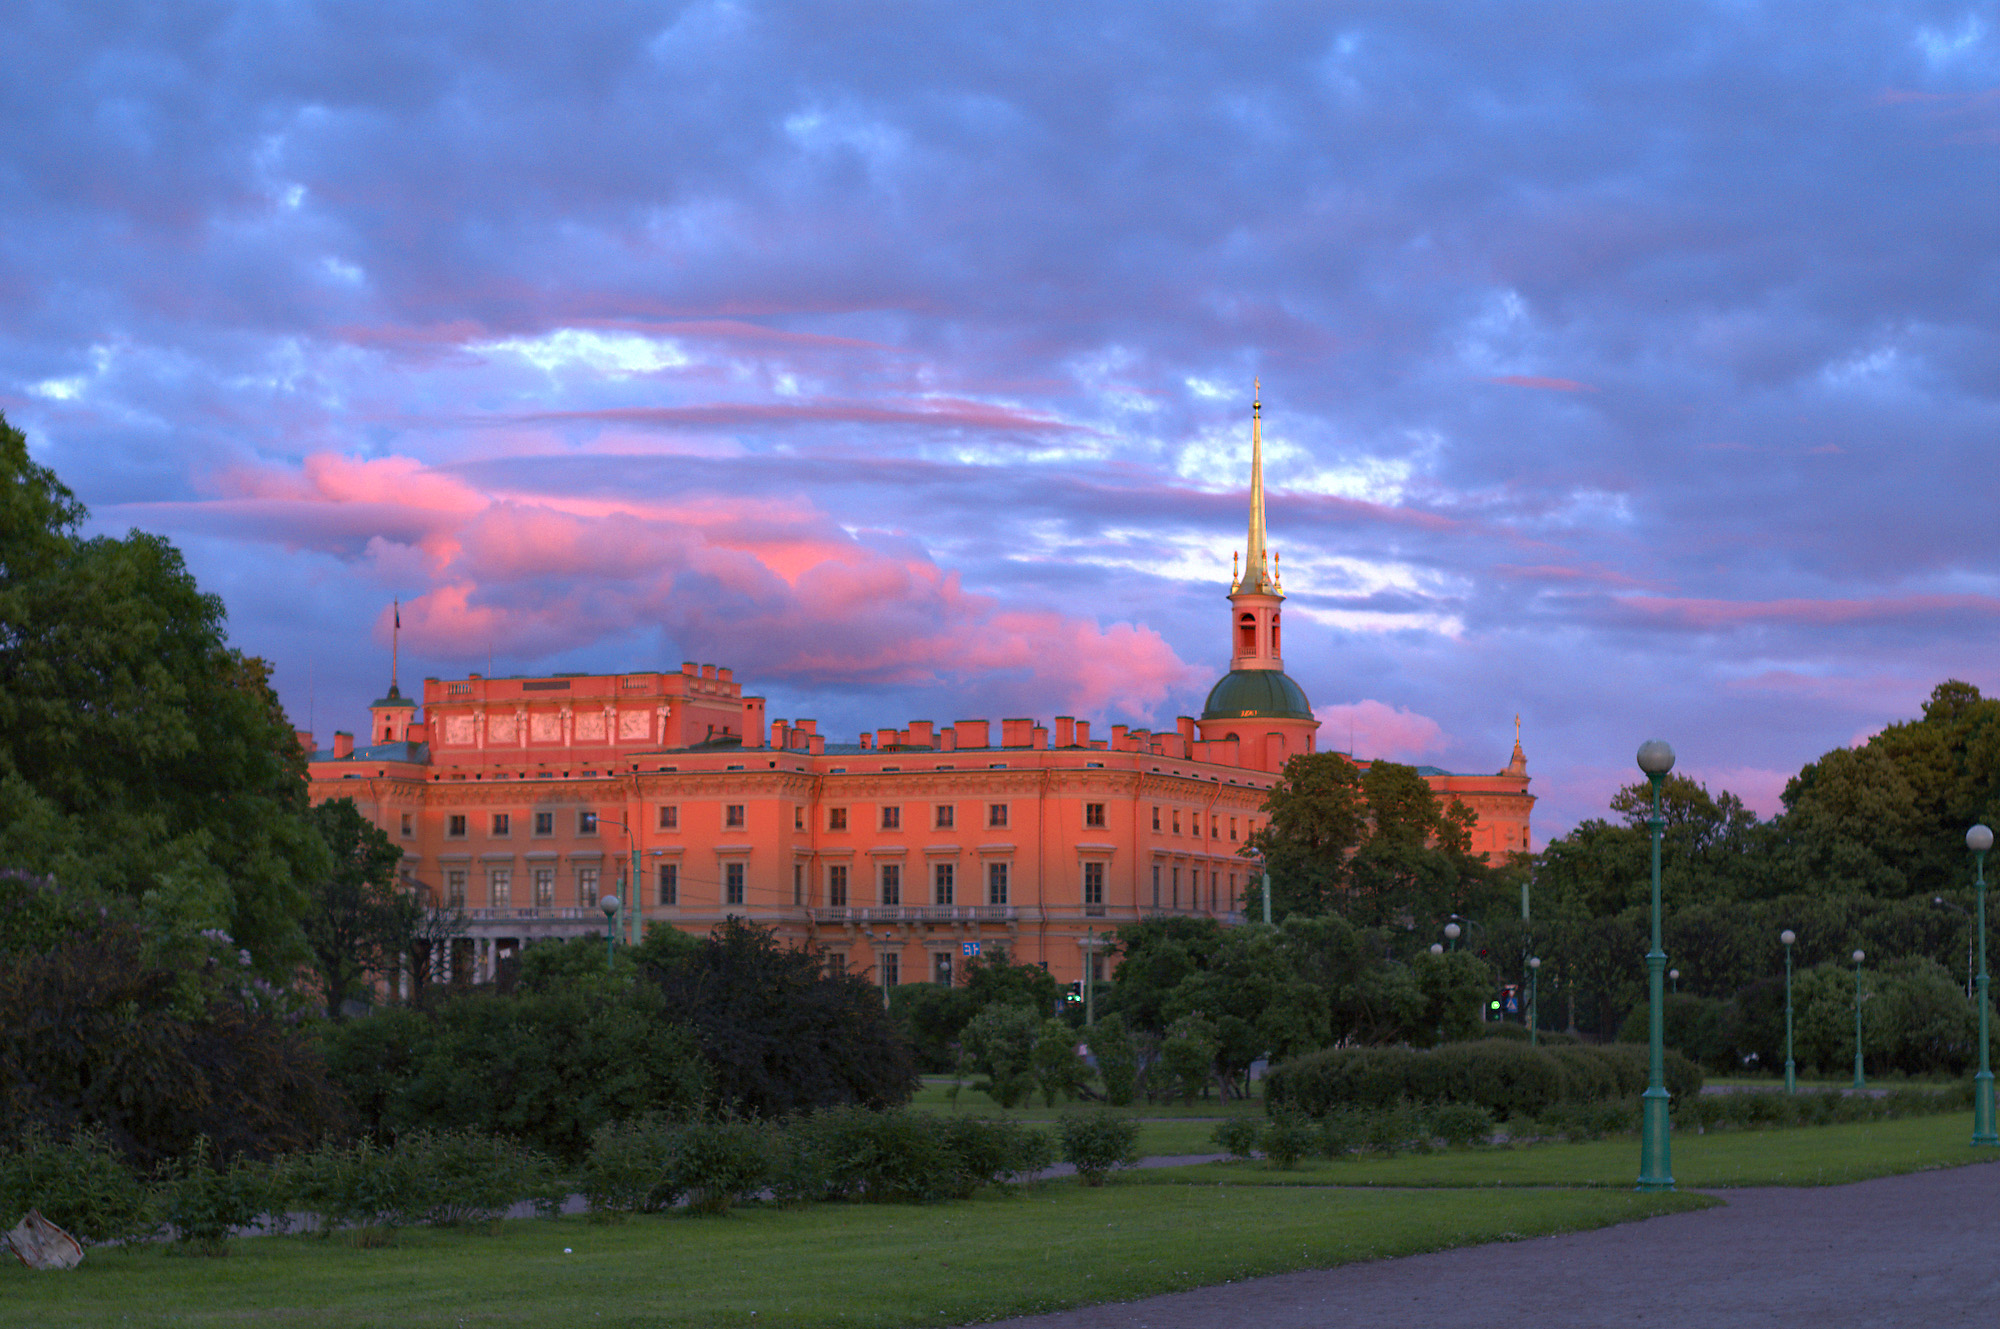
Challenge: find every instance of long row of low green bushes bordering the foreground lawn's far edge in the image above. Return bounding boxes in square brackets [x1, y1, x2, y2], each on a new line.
[0, 1107, 1138, 1255]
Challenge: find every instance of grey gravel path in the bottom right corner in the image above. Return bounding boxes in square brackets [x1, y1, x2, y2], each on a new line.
[976, 1161, 2000, 1329]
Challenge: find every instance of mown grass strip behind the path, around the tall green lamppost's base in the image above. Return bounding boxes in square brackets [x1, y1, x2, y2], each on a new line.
[1134, 1113, 2000, 1189]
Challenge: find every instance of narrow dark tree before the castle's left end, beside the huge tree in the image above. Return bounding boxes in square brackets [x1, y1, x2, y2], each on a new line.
[304, 799, 412, 1021]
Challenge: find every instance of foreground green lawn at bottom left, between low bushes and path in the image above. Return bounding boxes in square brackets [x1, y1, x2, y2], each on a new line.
[0, 1185, 1714, 1329]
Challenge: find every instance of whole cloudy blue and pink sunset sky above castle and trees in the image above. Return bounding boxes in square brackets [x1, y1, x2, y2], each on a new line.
[0, 0, 2000, 843]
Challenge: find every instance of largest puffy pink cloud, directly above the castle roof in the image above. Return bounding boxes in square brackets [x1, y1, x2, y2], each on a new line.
[172, 454, 1192, 729]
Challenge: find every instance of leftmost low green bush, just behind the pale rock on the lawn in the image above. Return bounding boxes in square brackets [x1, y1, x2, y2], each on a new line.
[0, 1127, 160, 1245]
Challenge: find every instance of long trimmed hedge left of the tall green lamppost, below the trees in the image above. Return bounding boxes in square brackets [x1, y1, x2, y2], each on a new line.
[1264, 1039, 1702, 1121]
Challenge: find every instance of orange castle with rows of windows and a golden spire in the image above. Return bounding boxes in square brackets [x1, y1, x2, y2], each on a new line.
[302, 394, 1534, 985]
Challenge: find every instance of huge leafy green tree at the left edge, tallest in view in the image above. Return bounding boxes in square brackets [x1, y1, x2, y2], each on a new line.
[0, 418, 326, 979]
